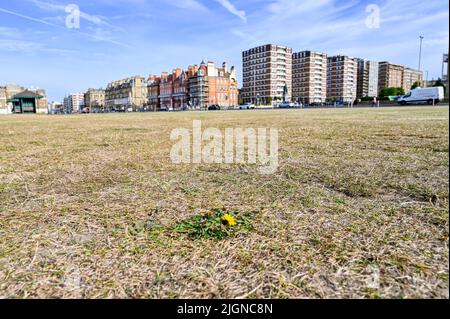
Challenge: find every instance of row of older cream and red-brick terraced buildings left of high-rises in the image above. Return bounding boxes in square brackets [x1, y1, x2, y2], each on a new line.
[77, 62, 239, 113]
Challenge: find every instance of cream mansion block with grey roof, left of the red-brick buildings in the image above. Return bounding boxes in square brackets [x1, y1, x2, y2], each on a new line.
[105, 76, 147, 112]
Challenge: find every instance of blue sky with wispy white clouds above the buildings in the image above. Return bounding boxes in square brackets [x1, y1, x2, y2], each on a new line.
[0, 0, 449, 101]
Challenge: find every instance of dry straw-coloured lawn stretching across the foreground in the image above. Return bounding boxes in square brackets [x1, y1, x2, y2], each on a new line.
[0, 106, 449, 298]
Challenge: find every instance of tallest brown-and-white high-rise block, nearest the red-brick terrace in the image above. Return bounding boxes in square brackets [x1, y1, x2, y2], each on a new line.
[242, 44, 292, 105]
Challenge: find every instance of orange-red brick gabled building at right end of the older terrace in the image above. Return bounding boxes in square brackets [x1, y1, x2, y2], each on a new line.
[189, 62, 239, 110]
